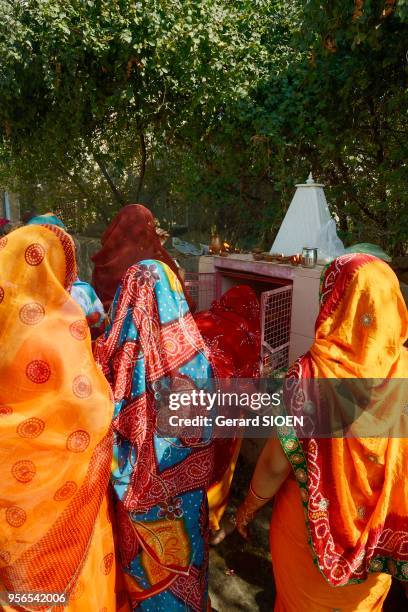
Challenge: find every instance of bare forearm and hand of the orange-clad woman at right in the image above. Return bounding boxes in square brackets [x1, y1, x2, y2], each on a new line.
[237, 438, 291, 538]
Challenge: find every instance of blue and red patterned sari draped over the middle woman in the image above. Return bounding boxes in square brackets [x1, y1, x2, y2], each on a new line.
[95, 260, 214, 612]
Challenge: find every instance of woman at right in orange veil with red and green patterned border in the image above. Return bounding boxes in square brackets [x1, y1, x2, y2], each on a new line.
[237, 254, 408, 612]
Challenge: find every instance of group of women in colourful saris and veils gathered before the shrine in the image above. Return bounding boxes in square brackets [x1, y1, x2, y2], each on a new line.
[0, 205, 408, 612]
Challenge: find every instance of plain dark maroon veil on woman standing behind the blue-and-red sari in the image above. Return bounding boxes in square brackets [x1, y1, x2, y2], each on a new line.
[92, 204, 194, 310]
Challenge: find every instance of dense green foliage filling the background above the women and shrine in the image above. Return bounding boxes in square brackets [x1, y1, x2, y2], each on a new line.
[0, 0, 408, 254]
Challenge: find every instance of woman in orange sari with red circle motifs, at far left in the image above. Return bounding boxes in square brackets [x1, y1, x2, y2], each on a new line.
[0, 226, 128, 612]
